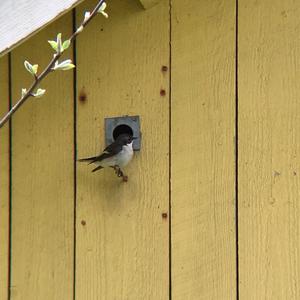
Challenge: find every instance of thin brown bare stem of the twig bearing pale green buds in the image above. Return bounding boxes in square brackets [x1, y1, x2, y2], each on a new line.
[0, 0, 105, 128]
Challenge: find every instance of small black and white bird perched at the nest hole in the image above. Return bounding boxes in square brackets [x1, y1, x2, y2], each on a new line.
[78, 133, 136, 181]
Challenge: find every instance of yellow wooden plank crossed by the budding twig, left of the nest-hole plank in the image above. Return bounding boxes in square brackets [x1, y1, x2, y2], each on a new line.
[11, 14, 74, 300]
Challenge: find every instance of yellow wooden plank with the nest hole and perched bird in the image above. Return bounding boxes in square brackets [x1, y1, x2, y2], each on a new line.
[76, 0, 169, 300]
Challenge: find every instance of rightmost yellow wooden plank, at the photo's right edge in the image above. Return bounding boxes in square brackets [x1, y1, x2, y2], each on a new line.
[238, 0, 300, 299]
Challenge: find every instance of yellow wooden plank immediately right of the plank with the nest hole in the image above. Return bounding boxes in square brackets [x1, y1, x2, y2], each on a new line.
[171, 0, 236, 300]
